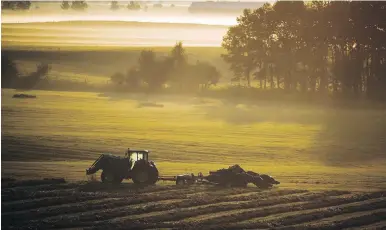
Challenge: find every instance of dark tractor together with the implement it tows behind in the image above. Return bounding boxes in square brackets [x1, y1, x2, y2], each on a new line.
[86, 149, 280, 189]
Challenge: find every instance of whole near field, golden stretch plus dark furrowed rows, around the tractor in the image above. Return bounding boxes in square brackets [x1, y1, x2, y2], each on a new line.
[2, 89, 386, 229]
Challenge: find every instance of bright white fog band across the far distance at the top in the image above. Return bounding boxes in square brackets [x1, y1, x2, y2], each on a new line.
[2, 2, 237, 25]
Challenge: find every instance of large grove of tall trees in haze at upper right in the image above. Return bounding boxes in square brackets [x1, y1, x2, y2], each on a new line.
[222, 1, 386, 99]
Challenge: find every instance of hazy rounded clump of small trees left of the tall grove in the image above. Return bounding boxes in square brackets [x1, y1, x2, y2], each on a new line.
[110, 42, 221, 92]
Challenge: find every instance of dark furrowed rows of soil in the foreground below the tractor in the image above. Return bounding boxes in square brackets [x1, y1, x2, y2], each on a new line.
[2, 181, 386, 229]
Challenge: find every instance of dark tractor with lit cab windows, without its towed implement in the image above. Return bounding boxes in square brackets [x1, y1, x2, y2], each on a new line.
[86, 148, 159, 185]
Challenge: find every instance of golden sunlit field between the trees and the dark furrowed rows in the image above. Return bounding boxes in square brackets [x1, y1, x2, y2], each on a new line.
[2, 89, 386, 190]
